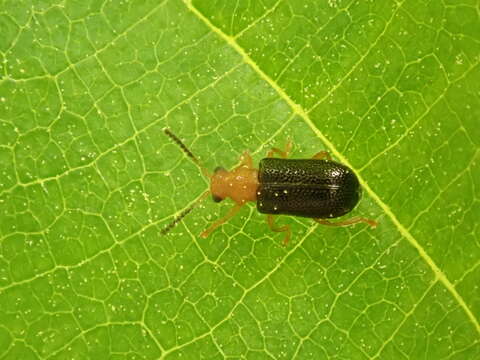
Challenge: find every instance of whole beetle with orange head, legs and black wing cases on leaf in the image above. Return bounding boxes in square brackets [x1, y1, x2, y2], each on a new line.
[162, 128, 377, 244]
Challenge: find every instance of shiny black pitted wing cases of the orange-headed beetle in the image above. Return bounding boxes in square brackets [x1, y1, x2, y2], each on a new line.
[257, 158, 361, 219]
